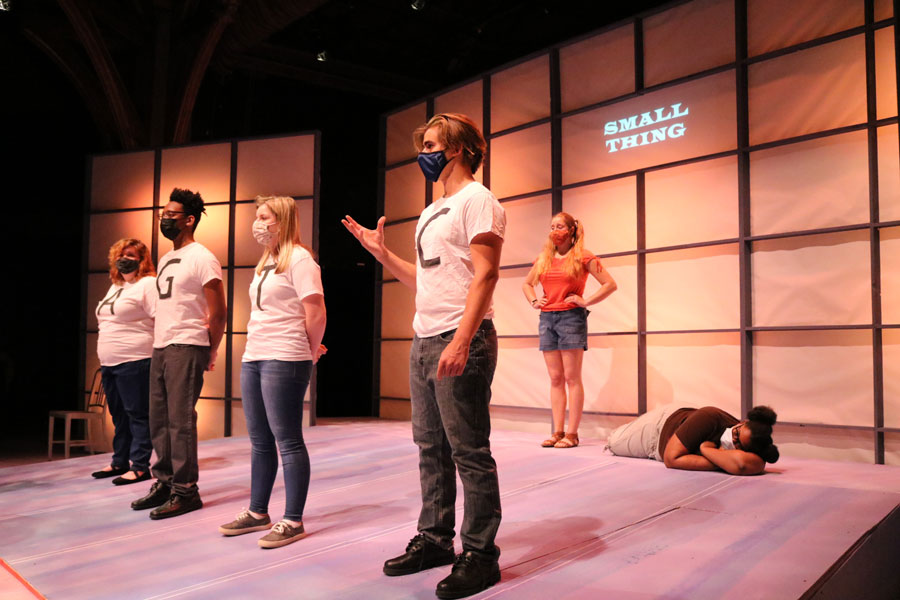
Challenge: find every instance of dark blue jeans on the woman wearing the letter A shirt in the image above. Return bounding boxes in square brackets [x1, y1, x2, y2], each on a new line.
[100, 358, 152, 471]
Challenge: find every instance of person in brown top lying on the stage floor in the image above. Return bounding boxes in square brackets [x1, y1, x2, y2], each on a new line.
[607, 404, 779, 475]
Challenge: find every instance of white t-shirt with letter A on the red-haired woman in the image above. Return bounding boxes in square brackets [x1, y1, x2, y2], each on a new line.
[96, 276, 158, 367]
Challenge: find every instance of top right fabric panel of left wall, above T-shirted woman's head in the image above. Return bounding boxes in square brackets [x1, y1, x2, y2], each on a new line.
[235, 134, 316, 200]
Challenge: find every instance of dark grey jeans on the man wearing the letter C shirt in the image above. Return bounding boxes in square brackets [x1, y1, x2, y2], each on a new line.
[409, 320, 500, 557]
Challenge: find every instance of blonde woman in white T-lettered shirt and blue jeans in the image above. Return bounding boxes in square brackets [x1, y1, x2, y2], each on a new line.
[219, 196, 325, 548]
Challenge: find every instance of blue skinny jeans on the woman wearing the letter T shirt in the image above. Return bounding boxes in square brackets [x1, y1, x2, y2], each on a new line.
[241, 360, 312, 521]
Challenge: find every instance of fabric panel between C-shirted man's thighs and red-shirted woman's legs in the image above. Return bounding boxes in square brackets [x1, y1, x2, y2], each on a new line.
[491, 337, 550, 410]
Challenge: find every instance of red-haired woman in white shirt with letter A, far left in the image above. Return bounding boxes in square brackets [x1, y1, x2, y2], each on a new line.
[92, 238, 157, 485]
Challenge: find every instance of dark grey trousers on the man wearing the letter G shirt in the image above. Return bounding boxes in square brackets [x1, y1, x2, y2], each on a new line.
[150, 344, 209, 496]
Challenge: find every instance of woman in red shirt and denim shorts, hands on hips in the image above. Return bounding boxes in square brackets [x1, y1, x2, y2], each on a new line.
[522, 212, 616, 448]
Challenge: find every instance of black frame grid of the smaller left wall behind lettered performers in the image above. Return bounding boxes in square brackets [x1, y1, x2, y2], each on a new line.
[78, 131, 321, 437]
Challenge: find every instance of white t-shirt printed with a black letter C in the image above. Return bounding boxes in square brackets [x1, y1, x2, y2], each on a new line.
[413, 181, 506, 337]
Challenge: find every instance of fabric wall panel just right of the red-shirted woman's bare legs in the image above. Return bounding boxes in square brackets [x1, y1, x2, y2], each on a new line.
[584, 335, 637, 414]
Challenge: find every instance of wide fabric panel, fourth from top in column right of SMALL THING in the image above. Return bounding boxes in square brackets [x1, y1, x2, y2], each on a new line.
[752, 231, 872, 326]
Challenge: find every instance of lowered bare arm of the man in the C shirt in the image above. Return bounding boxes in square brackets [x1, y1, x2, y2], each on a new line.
[437, 233, 503, 379]
